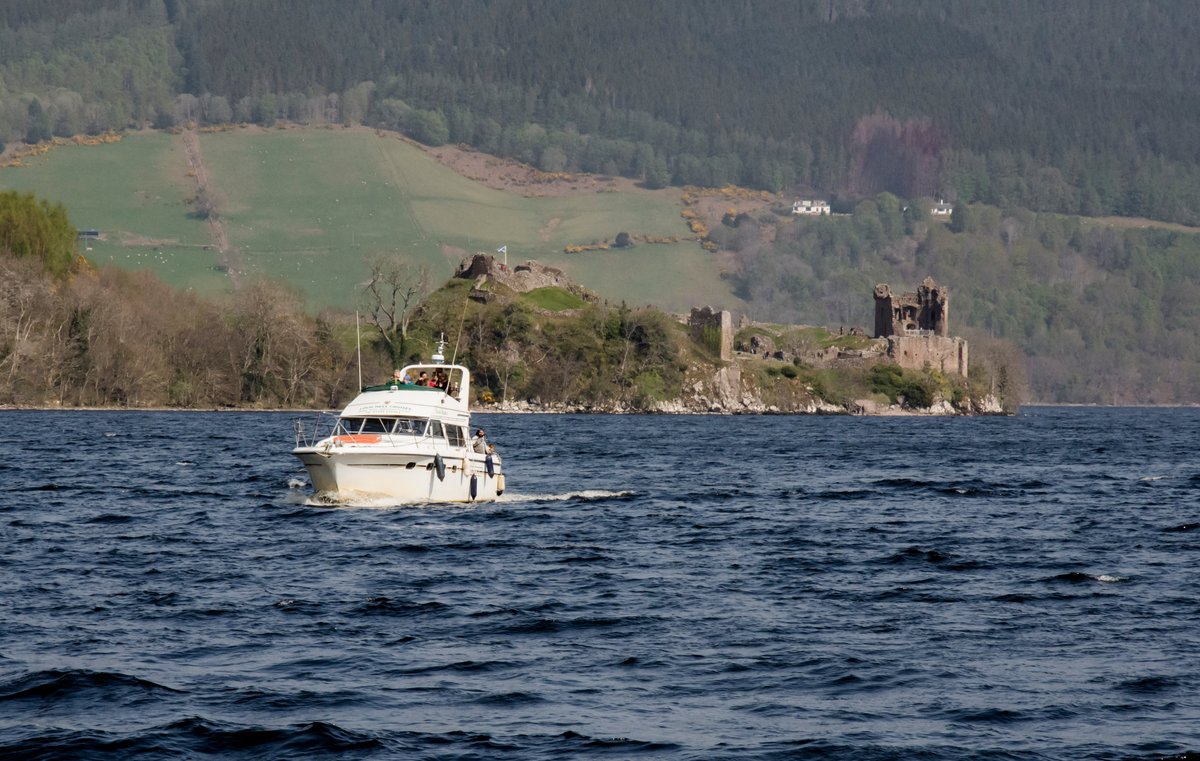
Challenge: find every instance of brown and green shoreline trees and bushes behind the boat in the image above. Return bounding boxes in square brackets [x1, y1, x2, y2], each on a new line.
[0, 193, 1022, 409]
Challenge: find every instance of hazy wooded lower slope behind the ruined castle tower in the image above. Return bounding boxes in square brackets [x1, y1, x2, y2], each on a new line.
[713, 193, 1200, 405]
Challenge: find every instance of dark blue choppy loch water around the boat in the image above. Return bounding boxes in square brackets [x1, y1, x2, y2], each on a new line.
[0, 409, 1200, 759]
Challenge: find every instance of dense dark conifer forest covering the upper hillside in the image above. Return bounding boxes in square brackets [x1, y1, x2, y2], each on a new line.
[0, 0, 1200, 224]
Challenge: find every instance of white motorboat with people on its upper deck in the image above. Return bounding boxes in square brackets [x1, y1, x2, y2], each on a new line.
[292, 344, 504, 502]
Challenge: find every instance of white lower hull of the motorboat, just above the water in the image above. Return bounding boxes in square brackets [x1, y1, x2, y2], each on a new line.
[293, 448, 503, 502]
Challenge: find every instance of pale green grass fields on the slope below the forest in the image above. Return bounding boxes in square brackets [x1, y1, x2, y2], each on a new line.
[0, 128, 738, 311]
